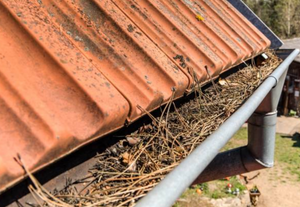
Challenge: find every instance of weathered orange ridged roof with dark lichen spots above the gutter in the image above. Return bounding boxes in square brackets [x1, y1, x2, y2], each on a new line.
[0, 0, 270, 191]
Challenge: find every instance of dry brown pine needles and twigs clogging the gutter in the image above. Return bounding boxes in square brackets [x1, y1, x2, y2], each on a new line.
[22, 52, 280, 206]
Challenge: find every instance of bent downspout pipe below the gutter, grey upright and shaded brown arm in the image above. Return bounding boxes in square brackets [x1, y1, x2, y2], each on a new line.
[193, 112, 277, 184]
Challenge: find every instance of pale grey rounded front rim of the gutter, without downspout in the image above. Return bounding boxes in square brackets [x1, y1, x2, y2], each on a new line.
[136, 49, 299, 207]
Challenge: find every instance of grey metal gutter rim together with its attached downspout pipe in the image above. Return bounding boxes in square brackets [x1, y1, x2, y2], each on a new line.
[136, 49, 299, 207]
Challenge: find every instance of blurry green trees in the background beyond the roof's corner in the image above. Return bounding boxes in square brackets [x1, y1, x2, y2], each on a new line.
[244, 0, 300, 38]
